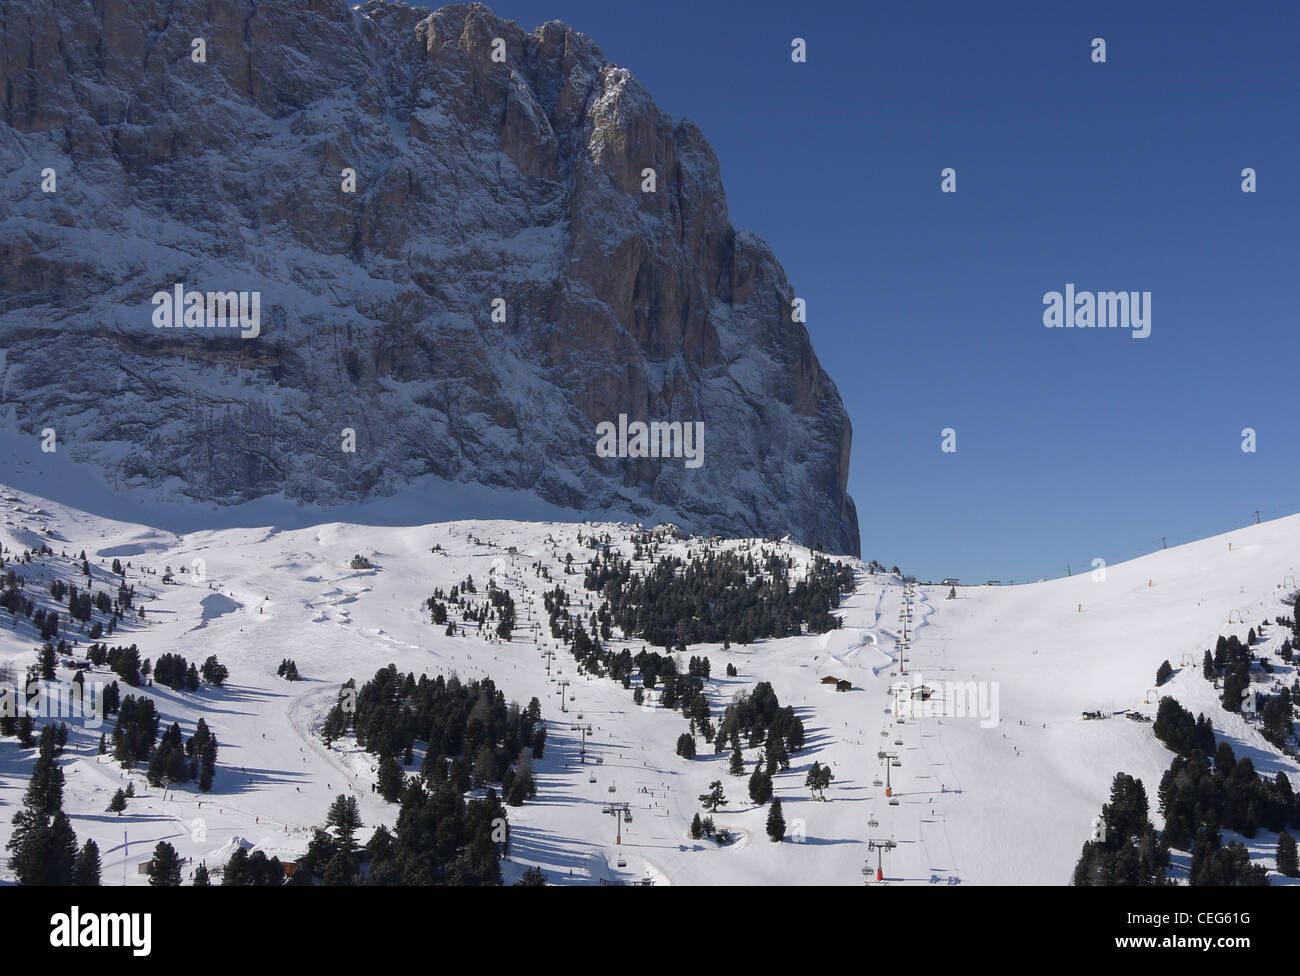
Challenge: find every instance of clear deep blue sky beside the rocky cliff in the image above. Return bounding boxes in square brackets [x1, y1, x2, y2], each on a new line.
[478, 0, 1300, 581]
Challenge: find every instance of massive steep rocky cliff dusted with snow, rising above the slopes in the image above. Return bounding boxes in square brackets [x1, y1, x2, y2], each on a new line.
[0, 0, 858, 552]
